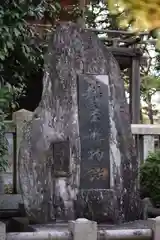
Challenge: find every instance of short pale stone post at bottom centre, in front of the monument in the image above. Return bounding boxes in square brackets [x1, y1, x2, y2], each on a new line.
[69, 218, 97, 240]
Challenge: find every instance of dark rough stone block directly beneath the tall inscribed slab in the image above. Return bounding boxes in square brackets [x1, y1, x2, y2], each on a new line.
[75, 189, 120, 224]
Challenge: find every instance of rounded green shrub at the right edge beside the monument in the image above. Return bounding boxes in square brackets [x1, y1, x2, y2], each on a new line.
[140, 150, 160, 205]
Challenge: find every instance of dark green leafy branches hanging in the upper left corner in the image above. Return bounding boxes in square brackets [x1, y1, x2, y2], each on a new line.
[0, 0, 60, 97]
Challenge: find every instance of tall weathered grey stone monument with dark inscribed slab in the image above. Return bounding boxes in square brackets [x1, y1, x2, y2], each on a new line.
[19, 23, 140, 223]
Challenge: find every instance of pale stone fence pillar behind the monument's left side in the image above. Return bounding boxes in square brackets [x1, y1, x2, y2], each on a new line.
[13, 109, 33, 192]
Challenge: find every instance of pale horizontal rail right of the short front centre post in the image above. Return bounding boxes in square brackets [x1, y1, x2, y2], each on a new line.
[100, 229, 152, 240]
